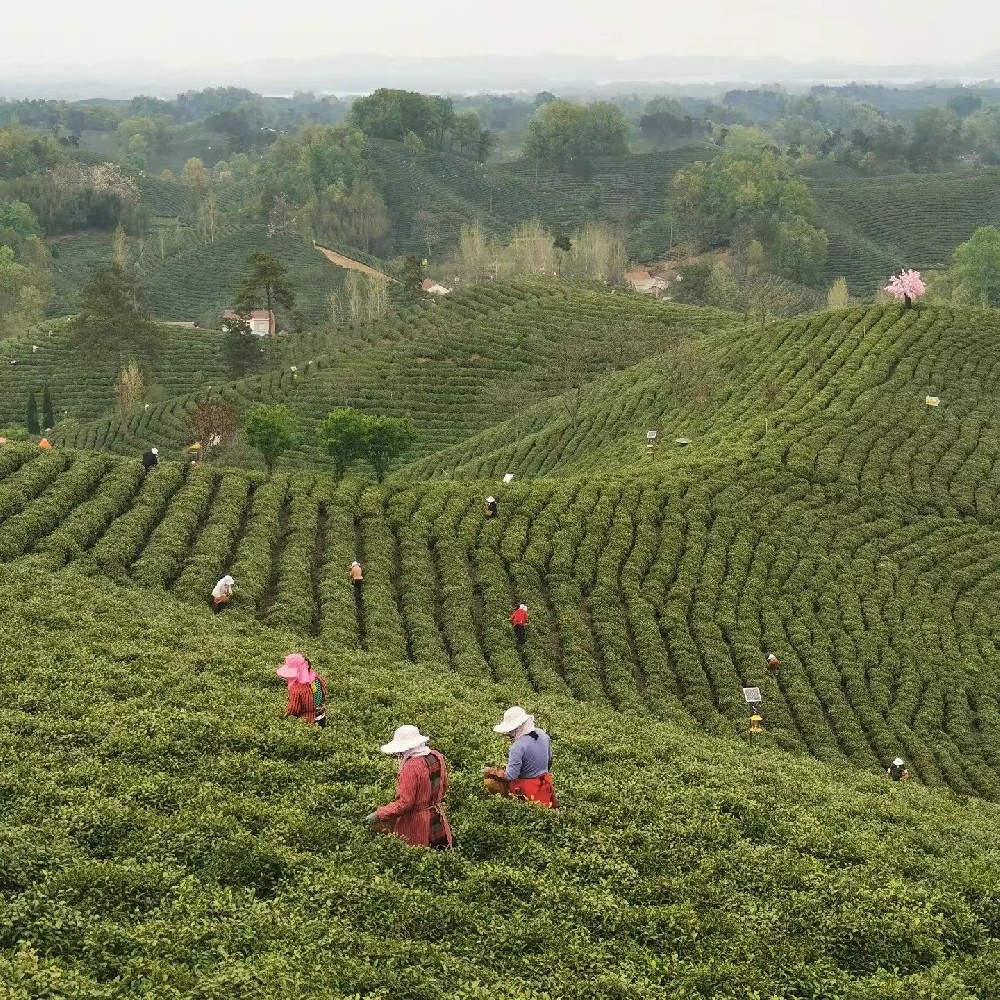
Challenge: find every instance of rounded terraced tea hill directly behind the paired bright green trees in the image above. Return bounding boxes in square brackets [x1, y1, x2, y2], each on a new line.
[59, 282, 732, 464]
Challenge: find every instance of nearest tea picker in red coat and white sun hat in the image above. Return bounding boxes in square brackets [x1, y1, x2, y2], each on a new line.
[365, 726, 454, 851]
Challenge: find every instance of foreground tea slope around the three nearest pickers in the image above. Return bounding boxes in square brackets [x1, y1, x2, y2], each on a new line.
[0, 567, 1000, 1000]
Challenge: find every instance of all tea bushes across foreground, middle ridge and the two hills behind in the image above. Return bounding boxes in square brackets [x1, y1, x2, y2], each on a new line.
[9, 281, 1000, 1000]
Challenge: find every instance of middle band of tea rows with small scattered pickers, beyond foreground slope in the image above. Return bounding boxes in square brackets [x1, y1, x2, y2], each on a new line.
[0, 438, 1000, 798]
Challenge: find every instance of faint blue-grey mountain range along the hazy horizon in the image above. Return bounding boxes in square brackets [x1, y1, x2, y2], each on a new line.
[0, 52, 1000, 100]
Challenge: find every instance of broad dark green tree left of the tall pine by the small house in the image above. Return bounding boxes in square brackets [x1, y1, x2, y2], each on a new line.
[70, 263, 157, 371]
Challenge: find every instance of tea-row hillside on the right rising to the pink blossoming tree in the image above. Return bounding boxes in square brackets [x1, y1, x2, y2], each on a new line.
[405, 306, 1000, 512]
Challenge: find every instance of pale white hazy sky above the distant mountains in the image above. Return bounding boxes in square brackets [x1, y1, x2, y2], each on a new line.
[0, 0, 1000, 69]
